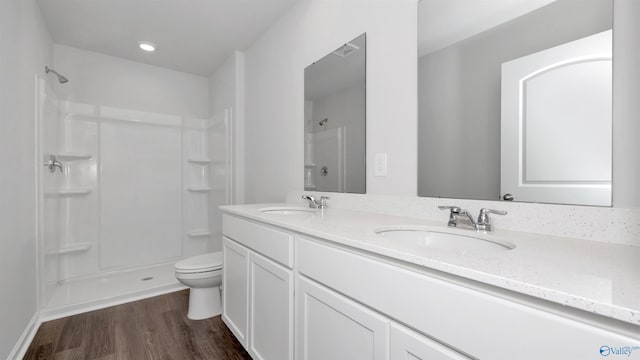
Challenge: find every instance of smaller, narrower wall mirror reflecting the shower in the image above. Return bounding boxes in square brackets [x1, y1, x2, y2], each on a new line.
[304, 34, 366, 194]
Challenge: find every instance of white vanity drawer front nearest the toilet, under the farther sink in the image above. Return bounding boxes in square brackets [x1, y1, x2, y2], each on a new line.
[222, 214, 293, 268]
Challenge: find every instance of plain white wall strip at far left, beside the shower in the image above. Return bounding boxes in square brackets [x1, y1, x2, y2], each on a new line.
[0, 0, 51, 359]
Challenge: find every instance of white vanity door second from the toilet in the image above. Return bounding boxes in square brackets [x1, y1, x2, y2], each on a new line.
[249, 251, 293, 360]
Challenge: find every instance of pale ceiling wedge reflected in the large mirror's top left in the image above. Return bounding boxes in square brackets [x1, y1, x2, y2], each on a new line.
[418, 0, 556, 56]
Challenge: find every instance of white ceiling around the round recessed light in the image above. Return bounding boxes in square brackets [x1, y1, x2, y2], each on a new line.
[38, 0, 296, 76]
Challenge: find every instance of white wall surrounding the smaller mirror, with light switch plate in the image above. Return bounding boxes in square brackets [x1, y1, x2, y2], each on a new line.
[246, 0, 418, 202]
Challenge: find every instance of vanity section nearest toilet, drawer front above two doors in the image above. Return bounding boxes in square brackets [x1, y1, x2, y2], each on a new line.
[222, 215, 294, 360]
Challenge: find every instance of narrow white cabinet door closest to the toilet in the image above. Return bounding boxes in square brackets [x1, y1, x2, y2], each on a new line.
[222, 238, 249, 348]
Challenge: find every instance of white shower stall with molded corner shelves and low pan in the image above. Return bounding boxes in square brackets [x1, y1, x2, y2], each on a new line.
[36, 68, 233, 319]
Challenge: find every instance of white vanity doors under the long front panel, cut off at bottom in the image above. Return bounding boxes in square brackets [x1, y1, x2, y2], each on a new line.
[295, 268, 469, 360]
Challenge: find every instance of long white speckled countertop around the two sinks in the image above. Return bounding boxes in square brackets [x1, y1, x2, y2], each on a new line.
[221, 204, 640, 326]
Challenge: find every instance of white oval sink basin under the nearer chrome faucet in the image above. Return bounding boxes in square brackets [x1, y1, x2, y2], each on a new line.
[375, 227, 516, 251]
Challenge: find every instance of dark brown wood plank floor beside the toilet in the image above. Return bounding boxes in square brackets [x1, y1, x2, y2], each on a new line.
[24, 290, 251, 360]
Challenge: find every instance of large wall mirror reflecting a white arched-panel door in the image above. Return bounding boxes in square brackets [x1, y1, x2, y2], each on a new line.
[418, 0, 613, 206]
